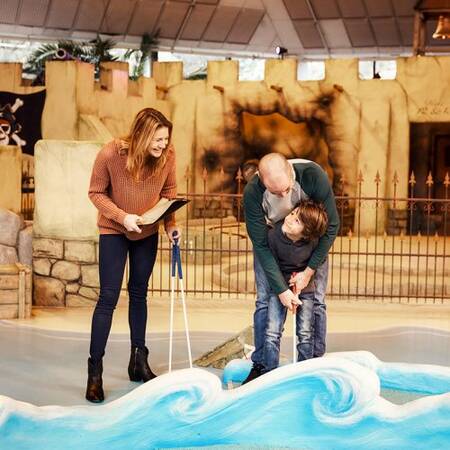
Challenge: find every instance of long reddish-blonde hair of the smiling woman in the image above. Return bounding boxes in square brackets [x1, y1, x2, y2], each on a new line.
[123, 108, 172, 180]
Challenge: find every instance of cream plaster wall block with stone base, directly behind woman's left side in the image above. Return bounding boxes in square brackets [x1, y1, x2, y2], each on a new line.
[33, 141, 127, 306]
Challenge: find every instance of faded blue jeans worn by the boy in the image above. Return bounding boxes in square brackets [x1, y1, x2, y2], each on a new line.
[264, 292, 314, 372]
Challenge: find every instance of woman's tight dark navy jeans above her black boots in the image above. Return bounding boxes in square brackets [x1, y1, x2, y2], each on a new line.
[89, 234, 158, 360]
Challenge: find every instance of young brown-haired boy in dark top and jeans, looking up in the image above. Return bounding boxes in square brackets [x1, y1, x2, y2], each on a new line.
[264, 200, 328, 372]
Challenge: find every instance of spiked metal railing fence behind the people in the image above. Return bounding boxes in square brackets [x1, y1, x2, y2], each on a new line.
[146, 171, 450, 303]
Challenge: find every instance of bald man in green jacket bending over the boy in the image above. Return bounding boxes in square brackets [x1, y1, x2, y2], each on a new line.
[244, 153, 339, 383]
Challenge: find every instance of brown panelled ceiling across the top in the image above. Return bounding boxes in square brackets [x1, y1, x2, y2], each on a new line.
[0, 0, 442, 57]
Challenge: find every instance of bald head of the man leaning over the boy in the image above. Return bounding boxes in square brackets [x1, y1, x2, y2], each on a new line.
[258, 153, 293, 197]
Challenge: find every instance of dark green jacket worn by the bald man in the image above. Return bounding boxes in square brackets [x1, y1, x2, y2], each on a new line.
[244, 162, 339, 295]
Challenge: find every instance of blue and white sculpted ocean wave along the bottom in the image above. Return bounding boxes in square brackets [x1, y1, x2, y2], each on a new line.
[0, 352, 450, 450]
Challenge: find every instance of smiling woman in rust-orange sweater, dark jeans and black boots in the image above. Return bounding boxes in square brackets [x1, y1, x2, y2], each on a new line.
[86, 108, 180, 402]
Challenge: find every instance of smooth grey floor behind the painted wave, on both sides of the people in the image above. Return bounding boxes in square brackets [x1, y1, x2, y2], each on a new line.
[0, 321, 450, 406]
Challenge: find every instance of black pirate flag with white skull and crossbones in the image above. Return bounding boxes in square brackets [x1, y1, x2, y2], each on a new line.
[0, 91, 45, 155]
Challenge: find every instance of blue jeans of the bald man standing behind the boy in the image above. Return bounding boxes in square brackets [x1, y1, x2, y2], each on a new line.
[252, 252, 328, 366]
